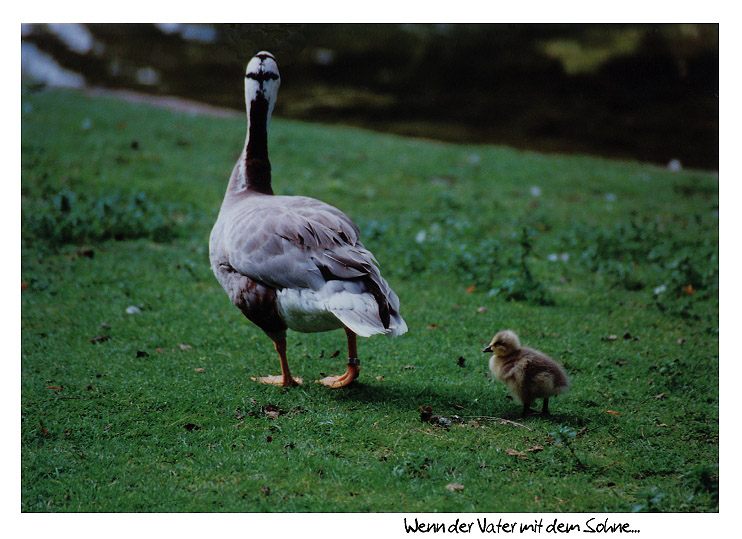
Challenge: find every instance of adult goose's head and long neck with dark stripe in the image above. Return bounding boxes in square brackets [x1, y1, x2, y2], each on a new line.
[241, 52, 281, 195]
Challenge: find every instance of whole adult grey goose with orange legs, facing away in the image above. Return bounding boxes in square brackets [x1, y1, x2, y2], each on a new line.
[209, 51, 407, 387]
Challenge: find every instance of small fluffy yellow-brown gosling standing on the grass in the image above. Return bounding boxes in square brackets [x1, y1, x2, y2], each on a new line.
[482, 329, 569, 416]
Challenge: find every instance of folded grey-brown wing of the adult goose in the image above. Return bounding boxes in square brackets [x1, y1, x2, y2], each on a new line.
[226, 197, 406, 333]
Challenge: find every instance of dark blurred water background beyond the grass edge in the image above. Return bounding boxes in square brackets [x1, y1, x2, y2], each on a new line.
[22, 24, 719, 169]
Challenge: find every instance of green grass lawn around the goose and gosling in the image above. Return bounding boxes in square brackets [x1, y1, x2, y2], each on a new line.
[21, 87, 719, 512]
